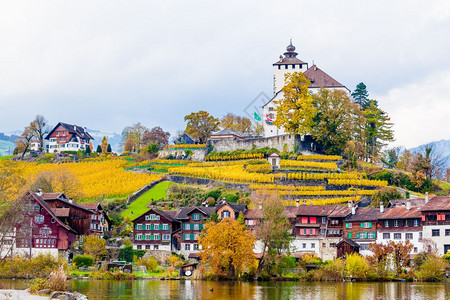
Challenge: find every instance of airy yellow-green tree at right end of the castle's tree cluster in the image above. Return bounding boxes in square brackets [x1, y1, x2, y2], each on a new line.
[363, 100, 394, 161]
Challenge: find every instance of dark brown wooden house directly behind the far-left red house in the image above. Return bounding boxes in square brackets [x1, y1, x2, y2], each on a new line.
[41, 193, 110, 236]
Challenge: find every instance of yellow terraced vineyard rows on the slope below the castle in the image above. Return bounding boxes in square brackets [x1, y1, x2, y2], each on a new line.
[167, 155, 387, 205]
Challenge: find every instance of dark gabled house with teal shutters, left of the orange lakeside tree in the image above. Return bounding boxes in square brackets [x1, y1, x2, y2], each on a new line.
[133, 208, 180, 251]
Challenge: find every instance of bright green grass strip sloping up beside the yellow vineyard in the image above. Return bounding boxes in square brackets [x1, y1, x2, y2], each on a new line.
[120, 181, 174, 220]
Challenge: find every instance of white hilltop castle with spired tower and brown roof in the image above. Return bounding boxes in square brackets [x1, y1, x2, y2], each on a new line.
[263, 40, 350, 137]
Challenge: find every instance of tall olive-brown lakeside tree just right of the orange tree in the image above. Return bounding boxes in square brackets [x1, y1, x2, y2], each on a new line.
[252, 191, 291, 276]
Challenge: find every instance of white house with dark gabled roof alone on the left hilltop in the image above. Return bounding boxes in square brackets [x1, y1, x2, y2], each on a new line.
[45, 122, 94, 153]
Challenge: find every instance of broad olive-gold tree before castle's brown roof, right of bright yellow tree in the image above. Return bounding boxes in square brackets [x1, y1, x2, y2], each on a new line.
[311, 89, 361, 154]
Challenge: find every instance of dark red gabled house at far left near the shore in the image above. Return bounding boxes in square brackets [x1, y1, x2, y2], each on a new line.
[11, 191, 77, 256]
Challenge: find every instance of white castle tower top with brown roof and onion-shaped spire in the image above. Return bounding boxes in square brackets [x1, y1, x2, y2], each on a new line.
[273, 39, 308, 95]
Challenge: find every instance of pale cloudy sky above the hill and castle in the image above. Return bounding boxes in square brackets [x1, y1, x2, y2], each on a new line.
[0, 0, 450, 148]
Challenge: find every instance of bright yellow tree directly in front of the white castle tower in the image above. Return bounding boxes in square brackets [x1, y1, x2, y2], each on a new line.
[273, 72, 316, 134]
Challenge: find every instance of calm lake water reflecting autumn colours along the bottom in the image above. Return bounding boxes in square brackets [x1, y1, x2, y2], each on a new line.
[0, 280, 450, 300]
